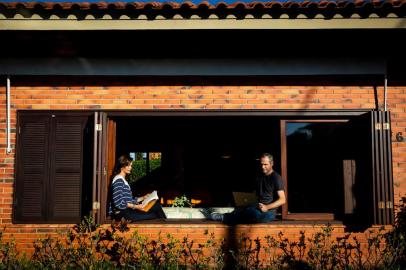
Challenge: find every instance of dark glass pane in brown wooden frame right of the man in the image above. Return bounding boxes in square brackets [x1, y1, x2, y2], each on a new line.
[286, 122, 345, 213]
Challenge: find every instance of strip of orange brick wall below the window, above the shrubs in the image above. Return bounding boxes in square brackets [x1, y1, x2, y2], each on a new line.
[3, 222, 389, 255]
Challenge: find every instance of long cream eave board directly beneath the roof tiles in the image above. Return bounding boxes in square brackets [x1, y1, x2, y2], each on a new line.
[0, 17, 406, 31]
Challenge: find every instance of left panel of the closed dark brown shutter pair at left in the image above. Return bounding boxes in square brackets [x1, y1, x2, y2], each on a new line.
[13, 116, 49, 223]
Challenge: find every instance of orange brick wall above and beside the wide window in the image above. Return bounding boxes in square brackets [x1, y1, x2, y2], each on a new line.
[0, 81, 406, 253]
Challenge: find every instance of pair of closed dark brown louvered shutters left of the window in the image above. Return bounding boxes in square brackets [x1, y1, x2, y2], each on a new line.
[13, 112, 88, 223]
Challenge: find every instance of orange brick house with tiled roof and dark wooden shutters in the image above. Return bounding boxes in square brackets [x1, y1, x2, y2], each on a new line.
[0, 0, 406, 253]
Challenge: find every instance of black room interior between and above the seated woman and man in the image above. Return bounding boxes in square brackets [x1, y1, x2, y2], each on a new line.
[112, 117, 280, 206]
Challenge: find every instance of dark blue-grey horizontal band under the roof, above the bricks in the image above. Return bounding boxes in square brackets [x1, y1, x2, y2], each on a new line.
[0, 58, 386, 76]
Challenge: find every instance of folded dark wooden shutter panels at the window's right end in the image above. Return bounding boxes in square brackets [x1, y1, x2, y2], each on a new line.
[346, 111, 394, 225]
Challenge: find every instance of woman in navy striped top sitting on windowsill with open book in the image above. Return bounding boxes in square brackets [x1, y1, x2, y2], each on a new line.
[110, 155, 166, 222]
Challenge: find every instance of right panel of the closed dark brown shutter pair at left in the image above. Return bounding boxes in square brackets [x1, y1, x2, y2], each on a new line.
[49, 116, 86, 222]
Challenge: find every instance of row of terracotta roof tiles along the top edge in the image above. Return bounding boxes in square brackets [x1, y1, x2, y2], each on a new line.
[0, 0, 406, 18]
